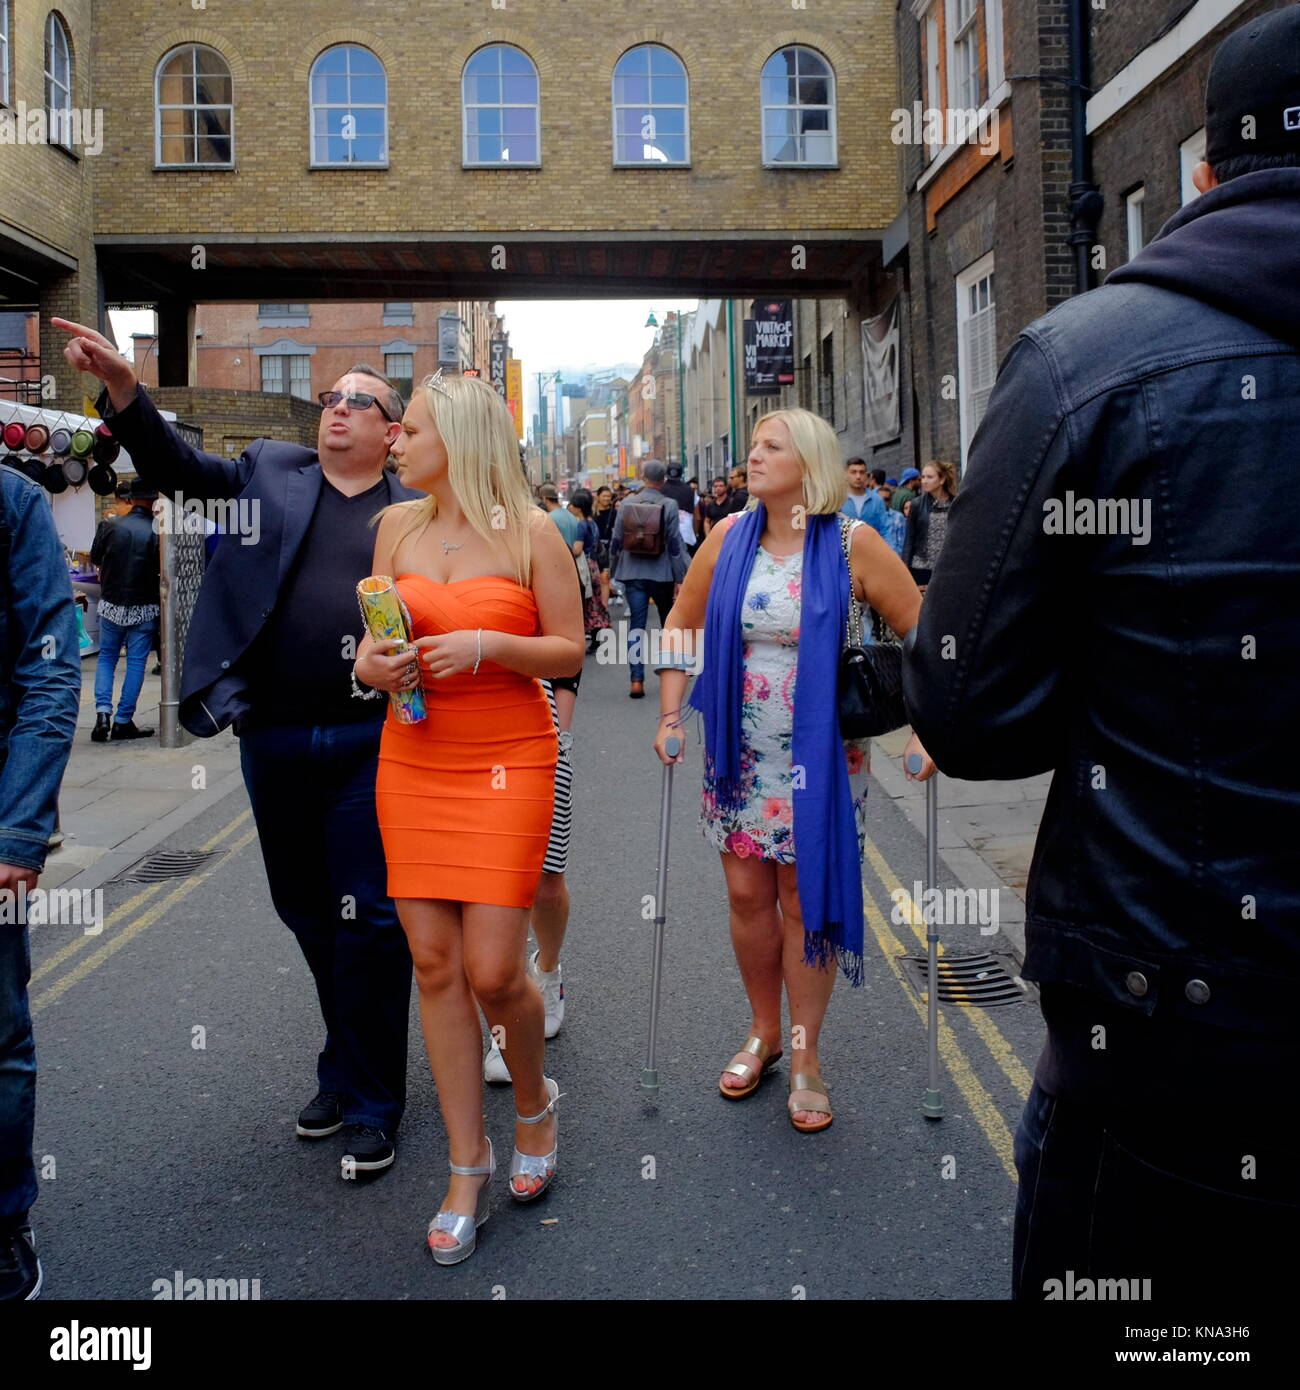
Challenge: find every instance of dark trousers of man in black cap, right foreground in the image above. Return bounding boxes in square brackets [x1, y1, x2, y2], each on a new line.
[1011, 1086, 1300, 1312]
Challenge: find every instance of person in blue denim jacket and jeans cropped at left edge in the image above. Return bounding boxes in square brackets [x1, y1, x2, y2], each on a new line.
[0, 466, 81, 1301]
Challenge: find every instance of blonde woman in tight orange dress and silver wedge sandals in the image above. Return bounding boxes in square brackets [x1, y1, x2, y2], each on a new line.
[356, 373, 584, 1265]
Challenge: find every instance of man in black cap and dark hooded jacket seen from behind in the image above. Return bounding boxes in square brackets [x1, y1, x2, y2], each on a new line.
[905, 6, 1300, 1307]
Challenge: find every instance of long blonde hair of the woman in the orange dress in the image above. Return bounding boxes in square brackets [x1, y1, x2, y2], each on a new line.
[380, 375, 537, 585]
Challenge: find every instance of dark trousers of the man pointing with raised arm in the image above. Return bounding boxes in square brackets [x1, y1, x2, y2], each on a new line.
[239, 719, 412, 1136]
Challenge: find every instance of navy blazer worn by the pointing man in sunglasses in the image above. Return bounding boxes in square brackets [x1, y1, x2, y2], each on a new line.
[97, 386, 424, 738]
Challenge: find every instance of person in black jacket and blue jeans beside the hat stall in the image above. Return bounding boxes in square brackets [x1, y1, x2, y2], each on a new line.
[90, 481, 160, 744]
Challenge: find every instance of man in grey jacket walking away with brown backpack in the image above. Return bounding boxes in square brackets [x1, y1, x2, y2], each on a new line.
[609, 459, 688, 699]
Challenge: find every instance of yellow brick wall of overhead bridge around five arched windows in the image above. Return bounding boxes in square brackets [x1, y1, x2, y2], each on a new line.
[91, 0, 898, 238]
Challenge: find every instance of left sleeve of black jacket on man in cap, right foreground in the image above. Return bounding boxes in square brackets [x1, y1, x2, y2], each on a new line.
[904, 335, 1078, 781]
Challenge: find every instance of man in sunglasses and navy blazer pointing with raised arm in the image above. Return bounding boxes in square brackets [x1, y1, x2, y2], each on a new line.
[51, 318, 420, 1177]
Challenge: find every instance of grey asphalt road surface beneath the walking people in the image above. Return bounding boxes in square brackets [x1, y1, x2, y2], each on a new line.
[32, 631, 1041, 1300]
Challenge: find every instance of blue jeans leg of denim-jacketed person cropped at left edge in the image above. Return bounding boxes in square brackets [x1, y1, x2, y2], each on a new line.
[0, 924, 36, 1230]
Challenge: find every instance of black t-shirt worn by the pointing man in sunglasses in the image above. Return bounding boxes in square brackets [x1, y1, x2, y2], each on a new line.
[242, 478, 388, 724]
